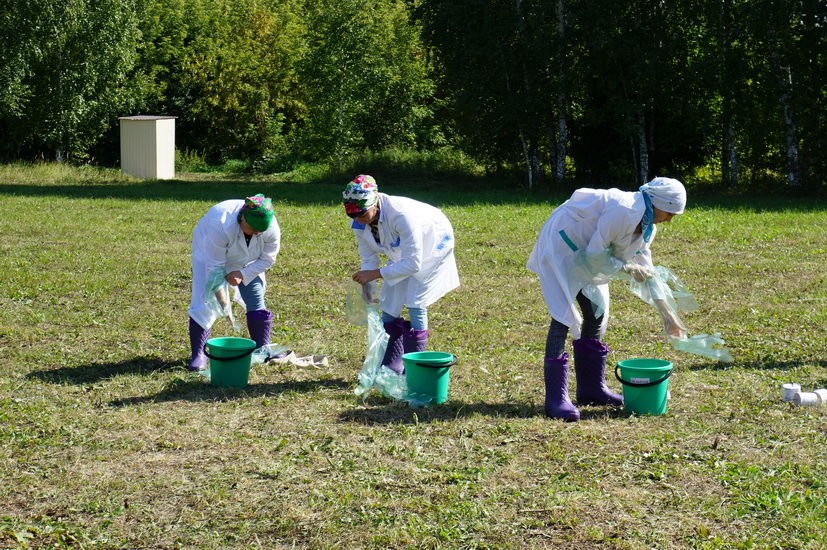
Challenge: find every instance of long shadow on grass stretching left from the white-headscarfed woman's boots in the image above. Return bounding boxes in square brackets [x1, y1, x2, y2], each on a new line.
[339, 399, 631, 426]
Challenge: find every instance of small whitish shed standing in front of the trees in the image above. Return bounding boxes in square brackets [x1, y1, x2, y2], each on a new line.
[118, 115, 177, 180]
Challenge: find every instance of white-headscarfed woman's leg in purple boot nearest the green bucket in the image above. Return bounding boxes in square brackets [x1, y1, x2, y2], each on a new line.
[572, 292, 623, 405]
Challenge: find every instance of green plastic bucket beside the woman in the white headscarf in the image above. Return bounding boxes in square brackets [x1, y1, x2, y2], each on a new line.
[615, 359, 672, 415]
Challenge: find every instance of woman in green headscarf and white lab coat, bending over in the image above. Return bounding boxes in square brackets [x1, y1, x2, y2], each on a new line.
[187, 194, 281, 371]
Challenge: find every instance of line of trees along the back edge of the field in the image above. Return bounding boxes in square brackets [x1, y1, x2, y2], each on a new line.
[0, 0, 827, 187]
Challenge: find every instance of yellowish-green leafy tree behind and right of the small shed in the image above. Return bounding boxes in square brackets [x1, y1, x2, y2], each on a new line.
[136, 0, 302, 161]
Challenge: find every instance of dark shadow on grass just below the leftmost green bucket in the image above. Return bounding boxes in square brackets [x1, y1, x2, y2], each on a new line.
[109, 378, 351, 407]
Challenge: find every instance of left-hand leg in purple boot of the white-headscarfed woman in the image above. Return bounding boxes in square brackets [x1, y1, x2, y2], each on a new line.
[543, 320, 580, 422]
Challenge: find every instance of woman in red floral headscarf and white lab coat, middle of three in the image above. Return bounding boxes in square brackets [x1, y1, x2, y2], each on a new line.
[342, 175, 459, 374]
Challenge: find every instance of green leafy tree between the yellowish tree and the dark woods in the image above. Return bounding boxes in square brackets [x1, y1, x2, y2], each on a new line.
[298, 0, 432, 165]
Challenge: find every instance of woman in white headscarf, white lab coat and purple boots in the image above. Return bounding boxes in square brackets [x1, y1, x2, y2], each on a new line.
[528, 178, 686, 421]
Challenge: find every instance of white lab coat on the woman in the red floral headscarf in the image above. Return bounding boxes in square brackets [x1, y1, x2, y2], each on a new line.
[351, 193, 459, 317]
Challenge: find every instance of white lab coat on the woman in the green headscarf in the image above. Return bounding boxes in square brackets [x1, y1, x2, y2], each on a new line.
[189, 200, 281, 329]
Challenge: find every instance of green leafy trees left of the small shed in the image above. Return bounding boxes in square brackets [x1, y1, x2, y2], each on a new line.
[0, 0, 140, 160]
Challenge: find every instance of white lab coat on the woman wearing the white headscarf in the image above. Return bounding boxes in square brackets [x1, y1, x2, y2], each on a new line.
[527, 188, 657, 338]
